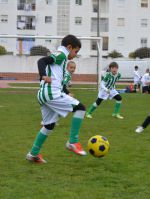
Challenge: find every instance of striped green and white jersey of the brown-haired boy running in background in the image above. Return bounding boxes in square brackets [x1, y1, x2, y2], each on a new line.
[101, 72, 121, 91]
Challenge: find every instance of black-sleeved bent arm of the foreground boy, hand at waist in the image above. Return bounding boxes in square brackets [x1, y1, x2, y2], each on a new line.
[38, 56, 54, 80]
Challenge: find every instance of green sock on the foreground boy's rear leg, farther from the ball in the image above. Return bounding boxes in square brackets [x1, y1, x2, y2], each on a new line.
[31, 131, 48, 156]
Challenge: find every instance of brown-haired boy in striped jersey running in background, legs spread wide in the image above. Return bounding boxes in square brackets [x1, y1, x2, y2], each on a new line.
[86, 62, 123, 119]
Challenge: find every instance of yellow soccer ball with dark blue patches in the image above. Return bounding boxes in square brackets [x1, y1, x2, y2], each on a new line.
[88, 135, 110, 157]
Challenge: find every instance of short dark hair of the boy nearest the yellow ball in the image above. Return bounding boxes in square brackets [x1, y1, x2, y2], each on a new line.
[61, 35, 81, 48]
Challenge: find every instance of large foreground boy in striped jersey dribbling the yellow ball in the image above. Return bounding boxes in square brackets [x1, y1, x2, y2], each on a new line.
[26, 35, 86, 163]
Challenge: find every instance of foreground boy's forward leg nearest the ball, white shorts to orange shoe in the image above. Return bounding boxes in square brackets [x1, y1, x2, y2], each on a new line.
[43, 94, 86, 155]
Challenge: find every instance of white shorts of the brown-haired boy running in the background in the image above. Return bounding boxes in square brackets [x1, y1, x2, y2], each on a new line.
[98, 89, 119, 100]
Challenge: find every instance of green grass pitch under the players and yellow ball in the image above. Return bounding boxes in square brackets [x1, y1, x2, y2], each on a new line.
[0, 88, 150, 199]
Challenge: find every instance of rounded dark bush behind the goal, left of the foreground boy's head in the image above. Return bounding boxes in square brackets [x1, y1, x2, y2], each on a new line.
[30, 45, 50, 56]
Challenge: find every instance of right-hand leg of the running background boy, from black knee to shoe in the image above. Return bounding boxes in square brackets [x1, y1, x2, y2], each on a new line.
[112, 94, 123, 119]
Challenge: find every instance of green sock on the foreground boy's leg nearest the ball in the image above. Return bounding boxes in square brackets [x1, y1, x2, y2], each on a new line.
[69, 117, 83, 143]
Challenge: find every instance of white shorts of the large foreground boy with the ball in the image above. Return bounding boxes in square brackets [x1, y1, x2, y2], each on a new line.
[41, 93, 79, 124]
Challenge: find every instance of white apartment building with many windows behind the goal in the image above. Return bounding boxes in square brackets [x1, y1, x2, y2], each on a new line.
[0, 0, 150, 56]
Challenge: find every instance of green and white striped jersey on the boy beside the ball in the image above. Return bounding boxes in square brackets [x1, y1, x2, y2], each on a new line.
[38, 46, 69, 105]
